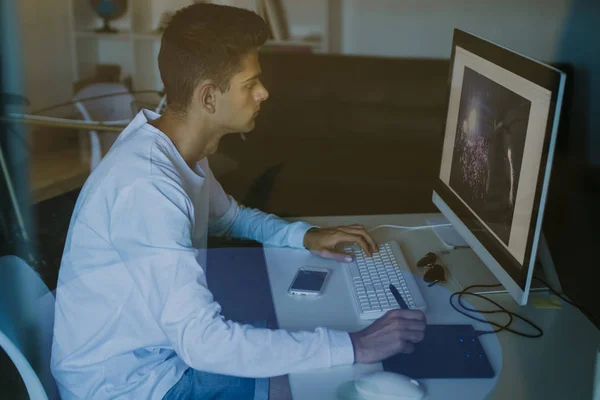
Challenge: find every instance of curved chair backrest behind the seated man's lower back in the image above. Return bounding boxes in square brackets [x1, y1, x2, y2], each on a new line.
[0, 256, 59, 400]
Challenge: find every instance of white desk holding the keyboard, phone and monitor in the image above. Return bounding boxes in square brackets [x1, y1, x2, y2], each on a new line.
[265, 214, 600, 400]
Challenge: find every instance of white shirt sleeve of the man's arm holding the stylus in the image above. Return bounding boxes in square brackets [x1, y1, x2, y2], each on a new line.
[110, 179, 354, 377]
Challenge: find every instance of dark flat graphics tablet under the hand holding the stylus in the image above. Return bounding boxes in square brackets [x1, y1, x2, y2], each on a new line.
[383, 325, 494, 379]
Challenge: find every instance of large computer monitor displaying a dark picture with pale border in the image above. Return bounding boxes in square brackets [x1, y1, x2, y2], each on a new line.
[433, 29, 565, 305]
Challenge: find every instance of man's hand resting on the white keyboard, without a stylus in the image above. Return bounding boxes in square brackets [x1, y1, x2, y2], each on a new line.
[304, 224, 379, 262]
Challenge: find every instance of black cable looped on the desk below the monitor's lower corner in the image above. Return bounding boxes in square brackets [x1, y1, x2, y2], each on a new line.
[450, 285, 544, 338]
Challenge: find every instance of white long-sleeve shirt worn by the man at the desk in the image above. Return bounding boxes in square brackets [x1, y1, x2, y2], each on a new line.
[52, 110, 354, 400]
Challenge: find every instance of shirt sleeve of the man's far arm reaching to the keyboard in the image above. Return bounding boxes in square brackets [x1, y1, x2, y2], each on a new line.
[207, 169, 315, 249]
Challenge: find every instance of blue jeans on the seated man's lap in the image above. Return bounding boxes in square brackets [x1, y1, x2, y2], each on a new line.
[163, 368, 269, 400]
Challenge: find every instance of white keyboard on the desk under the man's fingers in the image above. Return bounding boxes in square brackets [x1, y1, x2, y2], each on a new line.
[345, 241, 427, 320]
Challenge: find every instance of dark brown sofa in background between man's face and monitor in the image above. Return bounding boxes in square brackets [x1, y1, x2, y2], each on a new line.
[219, 53, 449, 215]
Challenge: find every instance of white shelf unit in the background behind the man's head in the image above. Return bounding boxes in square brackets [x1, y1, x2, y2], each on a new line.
[69, 0, 339, 90]
